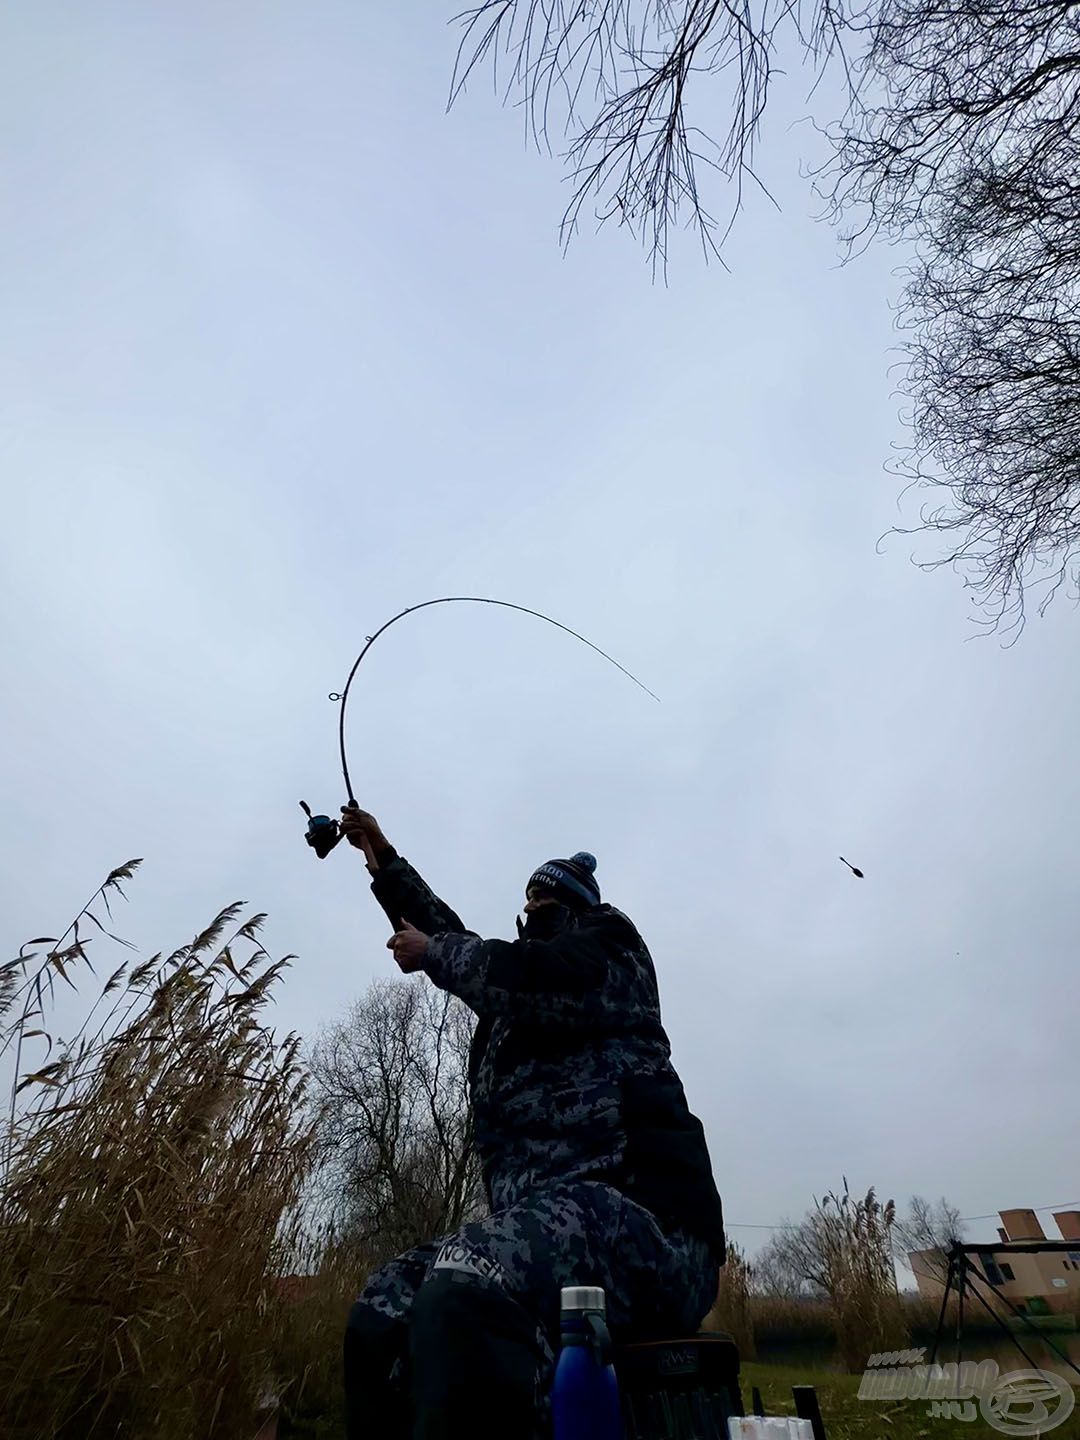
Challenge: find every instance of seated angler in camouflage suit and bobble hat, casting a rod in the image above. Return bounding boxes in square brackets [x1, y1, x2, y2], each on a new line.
[338, 812, 724, 1440]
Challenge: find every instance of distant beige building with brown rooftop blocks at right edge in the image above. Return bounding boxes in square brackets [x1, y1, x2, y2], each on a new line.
[907, 1210, 1080, 1310]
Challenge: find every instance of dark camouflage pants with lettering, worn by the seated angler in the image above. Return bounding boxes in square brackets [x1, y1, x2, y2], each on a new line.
[346, 1181, 717, 1440]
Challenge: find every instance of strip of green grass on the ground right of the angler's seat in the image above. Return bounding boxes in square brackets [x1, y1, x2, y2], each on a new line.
[742, 1364, 1080, 1440]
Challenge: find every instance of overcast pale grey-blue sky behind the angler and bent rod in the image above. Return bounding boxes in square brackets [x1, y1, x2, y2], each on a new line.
[0, 0, 1080, 1247]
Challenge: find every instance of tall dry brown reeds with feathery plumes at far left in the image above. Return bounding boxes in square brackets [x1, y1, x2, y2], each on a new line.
[0, 861, 311, 1440]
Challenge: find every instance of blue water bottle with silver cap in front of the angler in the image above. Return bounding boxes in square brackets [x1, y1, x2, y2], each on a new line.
[552, 1284, 622, 1440]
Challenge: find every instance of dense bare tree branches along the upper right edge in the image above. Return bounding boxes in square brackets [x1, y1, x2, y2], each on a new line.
[831, 0, 1080, 626]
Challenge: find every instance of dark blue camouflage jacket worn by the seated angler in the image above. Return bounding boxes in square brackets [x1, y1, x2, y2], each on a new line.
[372, 851, 723, 1261]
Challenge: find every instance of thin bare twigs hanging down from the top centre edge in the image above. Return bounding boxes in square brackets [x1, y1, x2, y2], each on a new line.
[451, 0, 844, 265]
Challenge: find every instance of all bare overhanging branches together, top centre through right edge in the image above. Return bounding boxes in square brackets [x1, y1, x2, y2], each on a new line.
[451, 0, 1080, 629]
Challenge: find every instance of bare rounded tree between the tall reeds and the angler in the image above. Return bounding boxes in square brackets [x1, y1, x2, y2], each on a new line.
[310, 981, 484, 1254]
